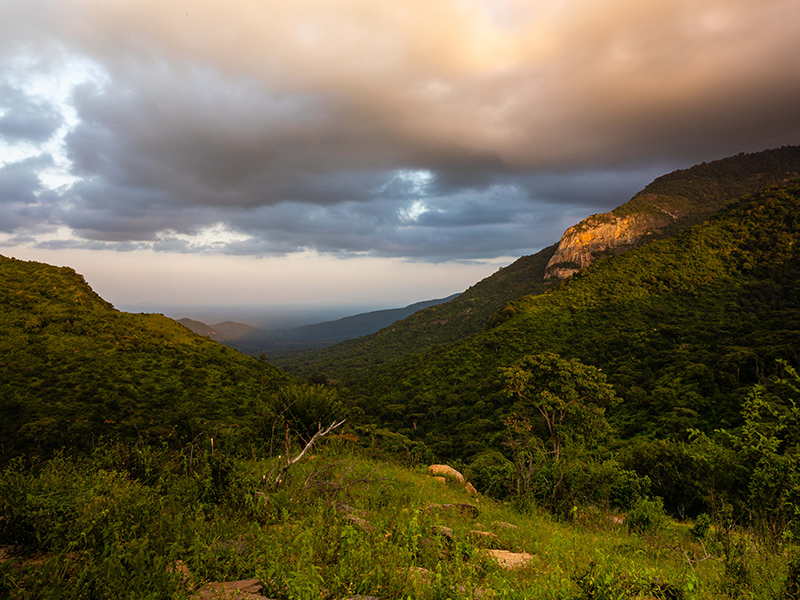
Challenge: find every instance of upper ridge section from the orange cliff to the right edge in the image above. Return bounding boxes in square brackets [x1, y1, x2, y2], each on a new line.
[547, 146, 800, 279]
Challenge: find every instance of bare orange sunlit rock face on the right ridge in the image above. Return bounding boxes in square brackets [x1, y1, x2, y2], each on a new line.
[545, 209, 678, 279]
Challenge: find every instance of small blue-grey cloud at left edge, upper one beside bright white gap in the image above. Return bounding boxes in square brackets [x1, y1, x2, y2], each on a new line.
[0, 81, 64, 143]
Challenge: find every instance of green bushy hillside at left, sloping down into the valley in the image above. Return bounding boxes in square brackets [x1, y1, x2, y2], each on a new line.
[0, 256, 289, 457]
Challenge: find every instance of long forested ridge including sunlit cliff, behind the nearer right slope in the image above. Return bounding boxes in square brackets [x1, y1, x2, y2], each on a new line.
[284, 146, 800, 379]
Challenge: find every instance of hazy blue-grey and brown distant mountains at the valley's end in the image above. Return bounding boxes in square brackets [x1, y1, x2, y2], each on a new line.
[178, 294, 458, 360]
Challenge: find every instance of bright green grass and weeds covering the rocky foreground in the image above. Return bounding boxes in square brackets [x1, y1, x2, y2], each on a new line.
[0, 438, 787, 600]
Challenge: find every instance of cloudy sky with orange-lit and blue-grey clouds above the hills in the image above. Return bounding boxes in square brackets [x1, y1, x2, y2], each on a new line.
[0, 0, 800, 318]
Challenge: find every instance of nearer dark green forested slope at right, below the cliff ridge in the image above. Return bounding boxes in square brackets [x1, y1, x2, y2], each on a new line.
[351, 181, 800, 458]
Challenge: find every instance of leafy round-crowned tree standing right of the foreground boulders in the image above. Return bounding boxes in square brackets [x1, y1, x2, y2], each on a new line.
[501, 353, 618, 461]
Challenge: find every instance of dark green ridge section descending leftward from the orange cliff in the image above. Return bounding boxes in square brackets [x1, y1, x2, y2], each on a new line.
[275, 246, 555, 378]
